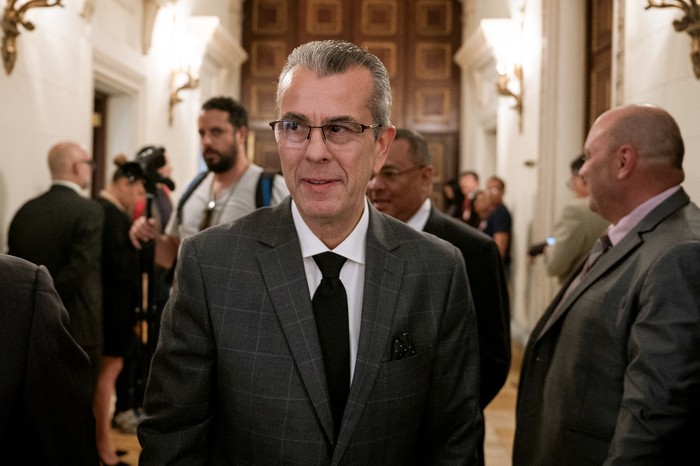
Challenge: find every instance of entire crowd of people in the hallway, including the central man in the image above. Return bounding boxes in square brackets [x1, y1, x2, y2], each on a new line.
[0, 40, 700, 466]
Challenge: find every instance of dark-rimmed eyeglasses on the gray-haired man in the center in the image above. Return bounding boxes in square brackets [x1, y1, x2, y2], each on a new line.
[270, 120, 382, 149]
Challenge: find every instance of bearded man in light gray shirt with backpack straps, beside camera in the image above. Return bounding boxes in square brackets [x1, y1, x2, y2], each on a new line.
[130, 97, 289, 264]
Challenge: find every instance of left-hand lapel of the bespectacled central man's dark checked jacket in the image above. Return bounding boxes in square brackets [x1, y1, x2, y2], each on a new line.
[258, 200, 333, 442]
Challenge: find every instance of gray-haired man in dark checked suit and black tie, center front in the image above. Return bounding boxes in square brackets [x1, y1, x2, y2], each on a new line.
[138, 41, 483, 465]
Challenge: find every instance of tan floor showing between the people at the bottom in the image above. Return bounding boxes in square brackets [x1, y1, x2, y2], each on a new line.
[112, 345, 522, 466]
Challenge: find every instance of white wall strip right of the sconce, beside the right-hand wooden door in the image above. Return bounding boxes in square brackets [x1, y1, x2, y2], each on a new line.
[512, 0, 586, 340]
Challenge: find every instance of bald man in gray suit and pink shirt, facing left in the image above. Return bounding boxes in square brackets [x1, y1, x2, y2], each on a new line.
[513, 105, 700, 466]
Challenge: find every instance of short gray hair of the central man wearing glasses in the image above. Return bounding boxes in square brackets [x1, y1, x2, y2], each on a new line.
[277, 40, 391, 130]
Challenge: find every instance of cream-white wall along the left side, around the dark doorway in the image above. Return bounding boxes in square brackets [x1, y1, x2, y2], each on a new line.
[0, 0, 247, 251]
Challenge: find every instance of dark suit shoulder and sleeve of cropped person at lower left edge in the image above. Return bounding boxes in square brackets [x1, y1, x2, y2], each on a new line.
[0, 262, 99, 466]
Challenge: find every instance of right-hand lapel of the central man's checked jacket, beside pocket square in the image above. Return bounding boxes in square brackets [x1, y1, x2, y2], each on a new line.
[332, 207, 404, 464]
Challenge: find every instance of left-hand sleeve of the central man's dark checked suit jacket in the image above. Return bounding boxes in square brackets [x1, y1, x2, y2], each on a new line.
[137, 238, 216, 465]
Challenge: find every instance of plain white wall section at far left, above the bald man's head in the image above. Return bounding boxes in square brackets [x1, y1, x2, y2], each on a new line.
[0, 1, 92, 251]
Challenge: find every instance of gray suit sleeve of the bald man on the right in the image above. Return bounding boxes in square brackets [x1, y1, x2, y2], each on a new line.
[605, 241, 700, 464]
